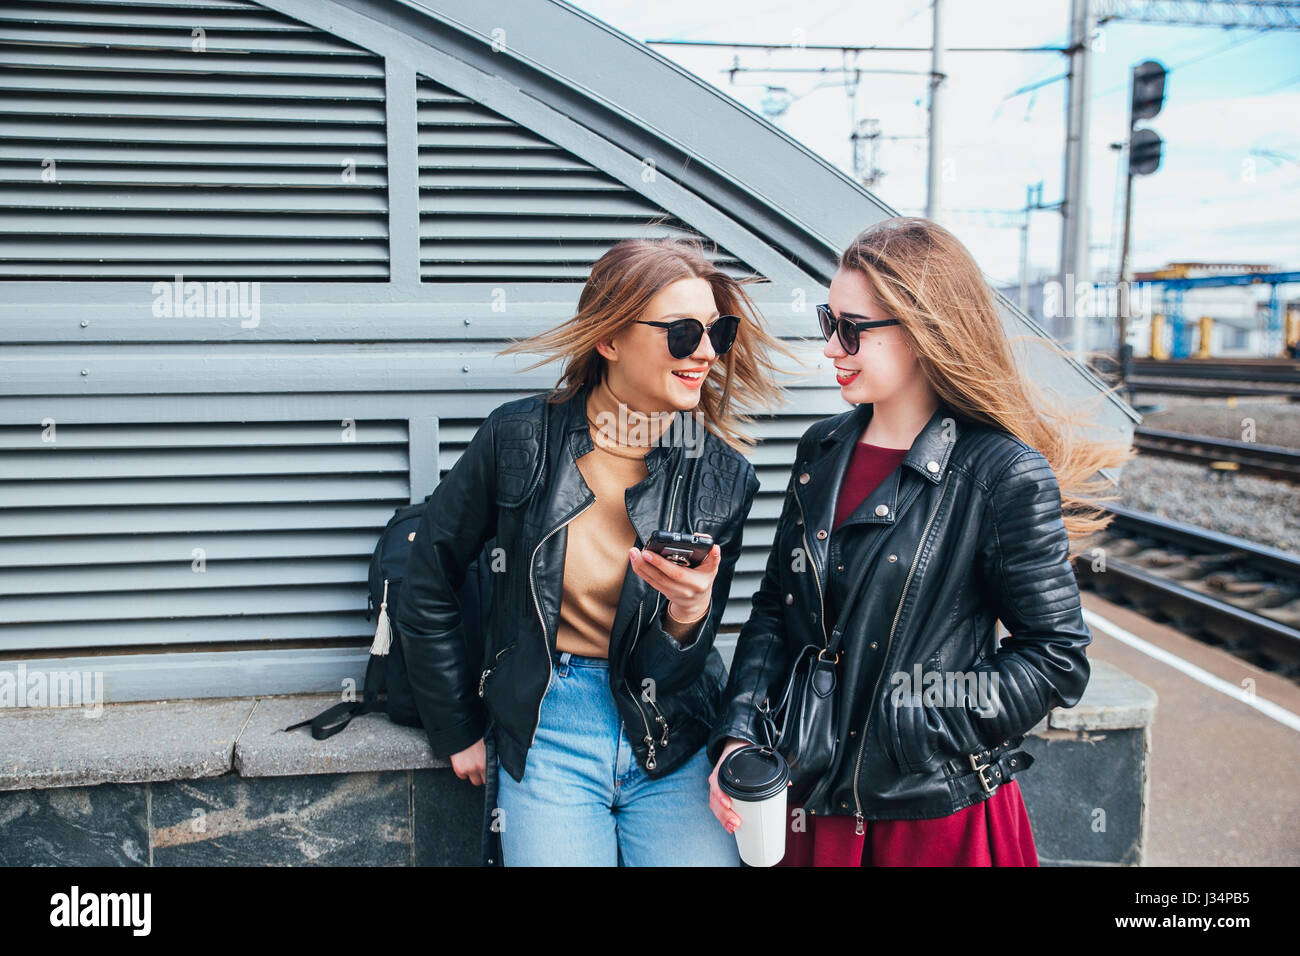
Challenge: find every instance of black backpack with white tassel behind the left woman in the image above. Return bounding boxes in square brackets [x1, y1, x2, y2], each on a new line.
[285, 493, 495, 740]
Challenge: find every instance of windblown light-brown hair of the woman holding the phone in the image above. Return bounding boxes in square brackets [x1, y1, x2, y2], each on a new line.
[501, 238, 798, 453]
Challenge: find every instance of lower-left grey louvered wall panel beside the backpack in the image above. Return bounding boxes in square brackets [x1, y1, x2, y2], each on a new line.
[0, 395, 437, 652]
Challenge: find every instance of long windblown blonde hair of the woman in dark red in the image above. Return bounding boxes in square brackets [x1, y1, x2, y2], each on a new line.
[840, 217, 1135, 558]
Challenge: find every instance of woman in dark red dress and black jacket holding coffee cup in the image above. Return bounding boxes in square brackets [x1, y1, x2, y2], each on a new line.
[709, 217, 1131, 866]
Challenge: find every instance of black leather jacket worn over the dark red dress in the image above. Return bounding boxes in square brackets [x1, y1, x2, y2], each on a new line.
[709, 403, 1092, 823]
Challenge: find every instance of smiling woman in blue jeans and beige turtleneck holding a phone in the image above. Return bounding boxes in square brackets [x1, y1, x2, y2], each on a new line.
[397, 239, 790, 866]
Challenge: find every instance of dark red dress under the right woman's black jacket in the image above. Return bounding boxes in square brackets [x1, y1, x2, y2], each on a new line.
[777, 441, 1039, 866]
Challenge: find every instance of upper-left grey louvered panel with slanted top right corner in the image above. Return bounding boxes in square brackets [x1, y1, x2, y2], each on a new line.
[0, 3, 389, 280]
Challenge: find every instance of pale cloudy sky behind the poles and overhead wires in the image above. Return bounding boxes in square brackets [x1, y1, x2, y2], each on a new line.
[575, 0, 1300, 285]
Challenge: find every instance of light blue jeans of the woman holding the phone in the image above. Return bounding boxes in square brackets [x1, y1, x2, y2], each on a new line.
[497, 653, 740, 866]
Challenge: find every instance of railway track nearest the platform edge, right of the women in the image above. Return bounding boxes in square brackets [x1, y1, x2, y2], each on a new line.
[1075, 505, 1300, 679]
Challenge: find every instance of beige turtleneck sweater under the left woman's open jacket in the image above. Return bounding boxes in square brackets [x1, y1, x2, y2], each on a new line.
[555, 381, 703, 657]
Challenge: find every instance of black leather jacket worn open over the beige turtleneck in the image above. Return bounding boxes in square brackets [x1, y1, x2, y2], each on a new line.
[395, 389, 758, 799]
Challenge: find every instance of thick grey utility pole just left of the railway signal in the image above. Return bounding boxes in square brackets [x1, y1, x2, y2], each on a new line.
[1061, 0, 1095, 362]
